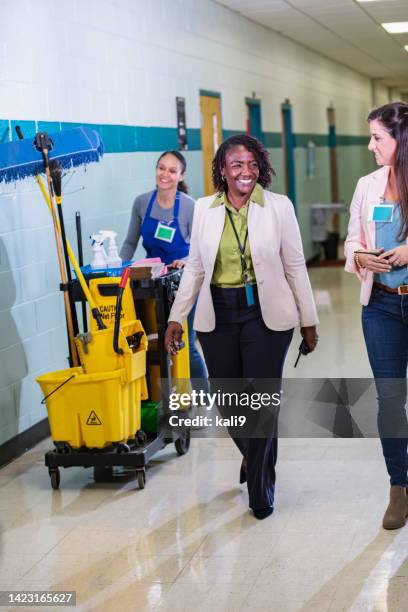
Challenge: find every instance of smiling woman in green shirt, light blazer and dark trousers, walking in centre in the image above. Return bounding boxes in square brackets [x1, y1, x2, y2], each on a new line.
[165, 134, 318, 519]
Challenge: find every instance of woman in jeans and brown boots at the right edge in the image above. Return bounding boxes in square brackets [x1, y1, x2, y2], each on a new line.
[345, 102, 408, 529]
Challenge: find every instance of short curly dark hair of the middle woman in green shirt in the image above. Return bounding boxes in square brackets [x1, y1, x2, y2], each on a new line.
[212, 134, 276, 192]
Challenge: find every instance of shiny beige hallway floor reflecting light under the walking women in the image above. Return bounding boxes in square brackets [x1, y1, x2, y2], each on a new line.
[0, 269, 408, 612]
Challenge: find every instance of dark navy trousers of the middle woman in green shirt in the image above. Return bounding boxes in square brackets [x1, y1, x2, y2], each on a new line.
[198, 286, 293, 510]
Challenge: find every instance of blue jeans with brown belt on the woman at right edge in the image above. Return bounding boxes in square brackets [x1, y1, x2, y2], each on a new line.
[362, 288, 408, 487]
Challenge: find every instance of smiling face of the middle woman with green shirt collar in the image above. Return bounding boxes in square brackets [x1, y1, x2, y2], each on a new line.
[222, 145, 259, 197]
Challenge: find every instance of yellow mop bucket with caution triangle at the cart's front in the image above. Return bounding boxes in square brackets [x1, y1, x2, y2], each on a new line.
[37, 367, 141, 448]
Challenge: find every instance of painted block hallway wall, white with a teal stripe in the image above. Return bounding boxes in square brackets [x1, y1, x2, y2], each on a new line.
[0, 0, 388, 444]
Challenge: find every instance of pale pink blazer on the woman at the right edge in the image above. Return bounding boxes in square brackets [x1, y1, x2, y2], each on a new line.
[344, 166, 408, 306]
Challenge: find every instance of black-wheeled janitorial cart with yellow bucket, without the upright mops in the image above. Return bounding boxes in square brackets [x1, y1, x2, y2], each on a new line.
[37, 269, 190, 488]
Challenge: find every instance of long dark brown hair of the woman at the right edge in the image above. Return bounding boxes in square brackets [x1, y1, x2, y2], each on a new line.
[367, 102, 408, 240]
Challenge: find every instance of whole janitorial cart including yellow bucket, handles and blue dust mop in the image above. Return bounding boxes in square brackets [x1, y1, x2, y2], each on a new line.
[0, 128, 190, 489]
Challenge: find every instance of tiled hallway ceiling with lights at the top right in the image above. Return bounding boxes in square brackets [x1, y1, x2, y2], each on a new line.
[218, 0, 408, 92]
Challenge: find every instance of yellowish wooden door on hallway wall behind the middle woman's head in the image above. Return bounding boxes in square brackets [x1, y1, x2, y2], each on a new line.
[200, 94, 222, 195]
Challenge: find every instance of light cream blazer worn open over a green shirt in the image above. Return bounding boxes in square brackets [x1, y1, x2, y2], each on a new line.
[169, 191, 319, 332]
